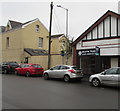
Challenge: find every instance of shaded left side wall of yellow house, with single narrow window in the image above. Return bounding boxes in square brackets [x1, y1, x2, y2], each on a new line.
[2, 29, 23, 63]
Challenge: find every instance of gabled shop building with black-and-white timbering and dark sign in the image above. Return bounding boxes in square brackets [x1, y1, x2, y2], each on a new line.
[72, 11, 120, 75]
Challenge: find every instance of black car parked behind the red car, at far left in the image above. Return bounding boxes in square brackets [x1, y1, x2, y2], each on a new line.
[1, 61, 19, 74]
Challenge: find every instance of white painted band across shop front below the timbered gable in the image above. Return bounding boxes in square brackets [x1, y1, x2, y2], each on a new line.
[76, 39, 120, 56]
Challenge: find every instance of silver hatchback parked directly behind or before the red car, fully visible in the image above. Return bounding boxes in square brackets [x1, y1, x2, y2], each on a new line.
[44, 65, 83, 82]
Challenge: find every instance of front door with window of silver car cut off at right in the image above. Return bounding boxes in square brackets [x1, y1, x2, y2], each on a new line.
[101, 68, 118, 85]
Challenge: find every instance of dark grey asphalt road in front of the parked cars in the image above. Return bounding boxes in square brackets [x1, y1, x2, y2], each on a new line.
[2, 74, 118, 109]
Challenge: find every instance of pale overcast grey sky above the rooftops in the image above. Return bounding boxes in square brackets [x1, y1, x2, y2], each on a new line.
[0, 0, 119, 40]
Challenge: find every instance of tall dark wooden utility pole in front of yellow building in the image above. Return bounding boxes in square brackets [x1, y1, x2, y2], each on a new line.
[48, 2, 53, 69]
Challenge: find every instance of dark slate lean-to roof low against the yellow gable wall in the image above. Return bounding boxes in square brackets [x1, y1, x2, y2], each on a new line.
[24, 48, 48, 56]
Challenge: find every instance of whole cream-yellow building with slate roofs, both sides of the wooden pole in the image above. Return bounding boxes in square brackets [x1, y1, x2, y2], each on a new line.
[0, 19, 72, 69]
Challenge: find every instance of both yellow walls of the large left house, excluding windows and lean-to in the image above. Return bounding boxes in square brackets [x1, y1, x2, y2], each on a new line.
[0, 20, 48, 63]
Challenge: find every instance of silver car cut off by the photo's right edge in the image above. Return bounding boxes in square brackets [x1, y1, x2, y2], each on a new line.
[89, 67, 120, 87]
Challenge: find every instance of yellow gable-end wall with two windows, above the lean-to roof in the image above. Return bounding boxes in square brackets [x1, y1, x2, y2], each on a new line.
[23, 20, 49, 50]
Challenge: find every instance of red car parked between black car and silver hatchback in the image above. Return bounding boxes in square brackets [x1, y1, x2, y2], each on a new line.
[15, 64, 44, 77]
